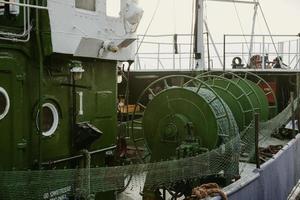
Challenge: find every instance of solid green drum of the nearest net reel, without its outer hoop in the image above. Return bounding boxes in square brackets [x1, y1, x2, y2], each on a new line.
[143, 87, 237, 161]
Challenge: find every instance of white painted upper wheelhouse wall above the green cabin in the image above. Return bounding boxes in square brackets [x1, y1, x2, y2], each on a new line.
[48, 0, 144, 61]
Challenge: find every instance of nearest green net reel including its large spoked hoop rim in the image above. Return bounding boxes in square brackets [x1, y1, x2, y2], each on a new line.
[131, 75, 239, 162]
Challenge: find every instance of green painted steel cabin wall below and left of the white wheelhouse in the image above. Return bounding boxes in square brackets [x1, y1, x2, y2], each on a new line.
[0, 0, 118, 199]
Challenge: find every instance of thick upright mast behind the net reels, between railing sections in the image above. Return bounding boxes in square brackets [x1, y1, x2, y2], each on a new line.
[194, 0, 205, 70]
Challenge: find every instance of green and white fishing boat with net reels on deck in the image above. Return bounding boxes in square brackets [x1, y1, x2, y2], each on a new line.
[0, 0, 300, 200]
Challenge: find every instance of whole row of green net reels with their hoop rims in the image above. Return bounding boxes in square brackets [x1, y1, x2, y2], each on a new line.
[131, 73, 277, 198]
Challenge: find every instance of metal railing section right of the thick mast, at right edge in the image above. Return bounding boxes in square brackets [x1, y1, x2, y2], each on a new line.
[223, 34, 300, 70]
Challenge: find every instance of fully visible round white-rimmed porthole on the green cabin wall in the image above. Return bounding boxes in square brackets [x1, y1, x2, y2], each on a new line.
[36, 103, 59, 137]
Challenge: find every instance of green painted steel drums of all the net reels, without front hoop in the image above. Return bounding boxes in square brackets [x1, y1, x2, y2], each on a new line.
[142, 75, 269, 160]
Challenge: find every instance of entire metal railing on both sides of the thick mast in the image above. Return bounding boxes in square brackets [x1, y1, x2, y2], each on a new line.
[134, 34, 300, 71]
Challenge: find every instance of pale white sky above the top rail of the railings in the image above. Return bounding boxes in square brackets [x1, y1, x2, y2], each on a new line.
[138, 0, 300, 41]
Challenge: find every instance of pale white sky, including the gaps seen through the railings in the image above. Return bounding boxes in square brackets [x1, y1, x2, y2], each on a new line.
[128, 0, 300, 68]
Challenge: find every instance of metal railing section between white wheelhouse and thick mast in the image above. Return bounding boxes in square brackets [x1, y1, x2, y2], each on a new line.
[134, 34, 194, 70]
